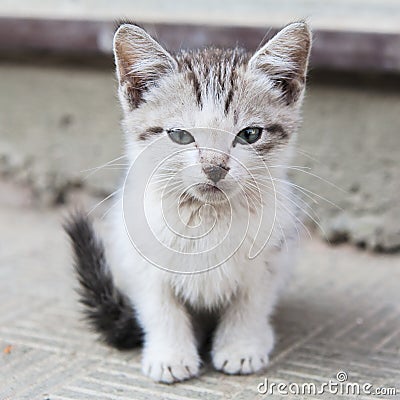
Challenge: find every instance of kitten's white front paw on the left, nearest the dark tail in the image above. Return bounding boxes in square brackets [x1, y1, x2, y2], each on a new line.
[142, 347, 201, 383]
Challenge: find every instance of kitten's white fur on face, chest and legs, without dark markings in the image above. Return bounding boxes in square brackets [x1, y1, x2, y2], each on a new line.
[108, 24, 308, 383]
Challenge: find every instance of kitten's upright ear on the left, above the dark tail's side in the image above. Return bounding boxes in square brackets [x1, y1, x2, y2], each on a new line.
[114, 24, 177, 109]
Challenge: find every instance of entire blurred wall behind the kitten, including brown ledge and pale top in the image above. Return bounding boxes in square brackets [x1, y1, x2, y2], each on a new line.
[0, 0, 400, 252]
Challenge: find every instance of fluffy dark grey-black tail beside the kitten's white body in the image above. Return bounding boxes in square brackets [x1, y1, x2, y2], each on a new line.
[64, 214, 143, 349]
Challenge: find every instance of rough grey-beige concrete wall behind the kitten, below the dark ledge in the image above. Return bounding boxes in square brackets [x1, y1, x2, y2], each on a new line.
[0, 62, 400, 251]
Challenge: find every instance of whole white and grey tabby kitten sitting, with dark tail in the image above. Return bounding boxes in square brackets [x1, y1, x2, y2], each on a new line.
[66, 22, 311, 383]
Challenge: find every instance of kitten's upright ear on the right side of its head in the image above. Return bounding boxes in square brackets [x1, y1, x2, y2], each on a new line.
[249, 22, 311, 105]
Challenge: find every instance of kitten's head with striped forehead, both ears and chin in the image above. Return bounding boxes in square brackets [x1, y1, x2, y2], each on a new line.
[114, 23, 311, 204]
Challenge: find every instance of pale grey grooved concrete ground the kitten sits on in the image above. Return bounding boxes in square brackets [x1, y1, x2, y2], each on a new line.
[0, 182, 400, 400]
